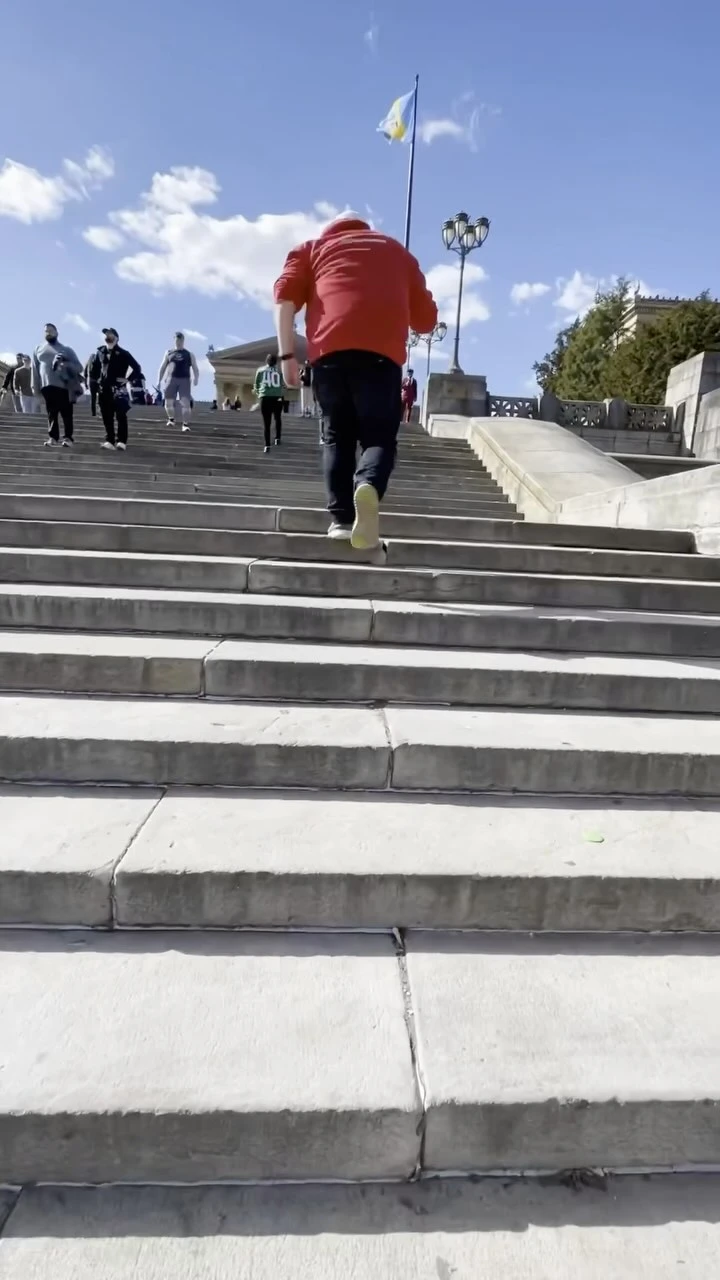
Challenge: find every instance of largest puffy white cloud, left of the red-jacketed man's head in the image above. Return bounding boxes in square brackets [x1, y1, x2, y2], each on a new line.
[82, 166, 340, 307]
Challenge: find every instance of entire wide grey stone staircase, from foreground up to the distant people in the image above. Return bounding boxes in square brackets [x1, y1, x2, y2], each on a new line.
[0, 415, 720, 1280]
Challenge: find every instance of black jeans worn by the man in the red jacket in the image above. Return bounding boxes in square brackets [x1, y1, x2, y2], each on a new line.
[313, 351, 402, 525]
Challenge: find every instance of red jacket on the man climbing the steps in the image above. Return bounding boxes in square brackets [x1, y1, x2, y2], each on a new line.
[274, 219, 437, 365]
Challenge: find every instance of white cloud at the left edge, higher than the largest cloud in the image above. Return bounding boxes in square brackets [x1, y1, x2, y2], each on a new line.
[0, 147, 114, 225]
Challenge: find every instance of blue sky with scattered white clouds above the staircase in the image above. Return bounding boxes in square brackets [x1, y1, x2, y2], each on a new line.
[0, 0, 720, 396]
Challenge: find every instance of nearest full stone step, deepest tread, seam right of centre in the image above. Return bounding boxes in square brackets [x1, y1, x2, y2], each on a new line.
[0, 931, 720, 1177]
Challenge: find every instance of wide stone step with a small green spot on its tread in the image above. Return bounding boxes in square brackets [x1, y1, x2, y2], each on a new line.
[0, 785, 720, 932]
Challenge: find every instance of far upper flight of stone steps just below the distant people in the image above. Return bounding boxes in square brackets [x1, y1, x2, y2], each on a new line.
[0, 402, 519, 520]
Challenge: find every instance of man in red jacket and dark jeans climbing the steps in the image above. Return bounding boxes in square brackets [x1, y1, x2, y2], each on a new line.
[275, 212, 437, 550]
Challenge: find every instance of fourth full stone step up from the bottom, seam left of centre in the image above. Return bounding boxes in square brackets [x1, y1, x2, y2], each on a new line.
[0, 631, 720, 716]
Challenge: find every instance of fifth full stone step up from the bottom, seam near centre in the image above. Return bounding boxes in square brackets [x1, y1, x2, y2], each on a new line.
[0, 582, 720, 658]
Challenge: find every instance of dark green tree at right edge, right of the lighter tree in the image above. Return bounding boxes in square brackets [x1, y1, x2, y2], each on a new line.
[603, 292, 720, 404]
